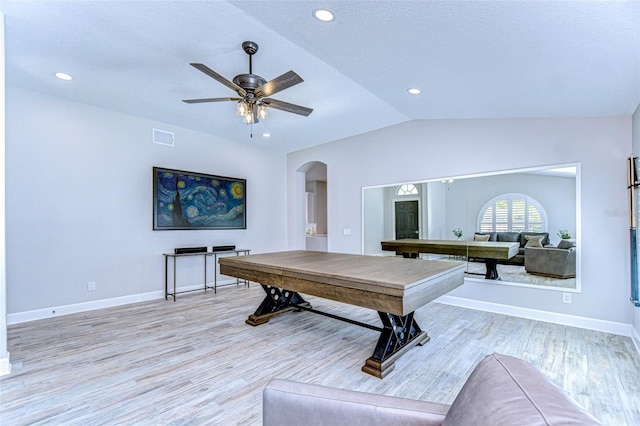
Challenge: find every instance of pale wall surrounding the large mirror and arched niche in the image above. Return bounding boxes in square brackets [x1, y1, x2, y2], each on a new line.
[287, 117, 633, 324]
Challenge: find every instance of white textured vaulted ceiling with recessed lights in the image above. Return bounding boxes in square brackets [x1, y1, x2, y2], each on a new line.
[0, 0, 640, 152]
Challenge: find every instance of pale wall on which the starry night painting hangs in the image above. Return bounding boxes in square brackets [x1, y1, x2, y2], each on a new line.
[6, 88, 286, 316]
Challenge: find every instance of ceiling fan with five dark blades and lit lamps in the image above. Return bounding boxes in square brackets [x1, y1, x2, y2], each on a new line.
[182, 41, 313, 124]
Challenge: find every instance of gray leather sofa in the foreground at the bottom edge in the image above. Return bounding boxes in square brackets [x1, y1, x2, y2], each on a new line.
[262, 354, 600, 426]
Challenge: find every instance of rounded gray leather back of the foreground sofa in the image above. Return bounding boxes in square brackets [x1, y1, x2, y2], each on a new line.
[442, 354, 600, 426]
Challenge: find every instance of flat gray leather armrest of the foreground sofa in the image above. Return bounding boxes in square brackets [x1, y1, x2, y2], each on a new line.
[262, 379, 449, 426]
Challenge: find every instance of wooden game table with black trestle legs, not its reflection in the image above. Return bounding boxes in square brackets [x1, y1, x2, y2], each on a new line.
[218, 250, 464, 378]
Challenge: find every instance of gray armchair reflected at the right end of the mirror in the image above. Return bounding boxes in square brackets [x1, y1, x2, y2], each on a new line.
[524, 240, 576, 278]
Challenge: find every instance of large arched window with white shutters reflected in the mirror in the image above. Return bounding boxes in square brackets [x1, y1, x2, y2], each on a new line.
[477, 194, 547, 232]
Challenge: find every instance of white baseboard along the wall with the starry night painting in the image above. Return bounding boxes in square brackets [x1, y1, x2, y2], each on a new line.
[7, 279, 242, 325]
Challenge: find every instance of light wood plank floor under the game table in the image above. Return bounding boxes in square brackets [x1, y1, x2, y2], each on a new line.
[0, 285, 640, 425]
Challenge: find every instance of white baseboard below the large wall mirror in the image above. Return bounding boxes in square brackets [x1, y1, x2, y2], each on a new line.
[435, 295, 640, 338]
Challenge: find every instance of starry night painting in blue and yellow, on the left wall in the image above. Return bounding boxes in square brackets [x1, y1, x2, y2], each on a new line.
[153, 167, 247, 230]
